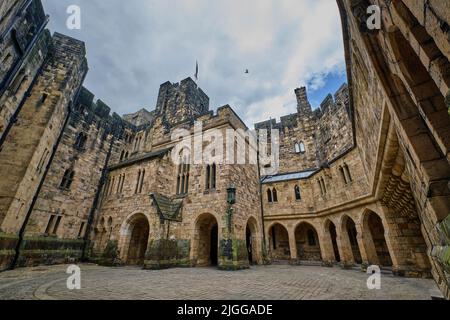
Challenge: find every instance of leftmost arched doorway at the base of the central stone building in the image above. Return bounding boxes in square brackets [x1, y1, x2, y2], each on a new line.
[124, 213, 150, 265]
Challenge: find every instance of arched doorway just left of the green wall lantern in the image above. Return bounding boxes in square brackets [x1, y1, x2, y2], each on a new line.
[193, 213, 219, 267]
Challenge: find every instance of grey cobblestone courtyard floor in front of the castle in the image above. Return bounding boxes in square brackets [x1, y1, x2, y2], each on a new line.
[0, 265, 437, 300]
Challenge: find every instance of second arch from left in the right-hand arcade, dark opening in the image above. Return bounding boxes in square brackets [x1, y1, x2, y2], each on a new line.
[295, 222, 322, 261]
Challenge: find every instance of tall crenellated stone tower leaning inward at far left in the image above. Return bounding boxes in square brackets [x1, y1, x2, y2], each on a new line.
[0, 28, 87, 263]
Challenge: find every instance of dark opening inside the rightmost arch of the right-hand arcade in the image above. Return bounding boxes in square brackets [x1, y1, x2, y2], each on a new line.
[364, 211, 392, 267]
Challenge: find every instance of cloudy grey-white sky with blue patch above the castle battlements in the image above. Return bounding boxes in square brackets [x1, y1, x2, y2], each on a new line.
[43, 0, 346, 127]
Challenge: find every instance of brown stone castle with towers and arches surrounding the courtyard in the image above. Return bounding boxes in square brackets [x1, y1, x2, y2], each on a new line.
[0, 0, 450, 298]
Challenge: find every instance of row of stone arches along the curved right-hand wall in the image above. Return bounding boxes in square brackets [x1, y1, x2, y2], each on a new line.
[266, 209, 430, 277]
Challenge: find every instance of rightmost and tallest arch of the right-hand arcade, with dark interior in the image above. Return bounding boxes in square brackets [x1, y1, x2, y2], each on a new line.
[363, 210, 392, 267]
